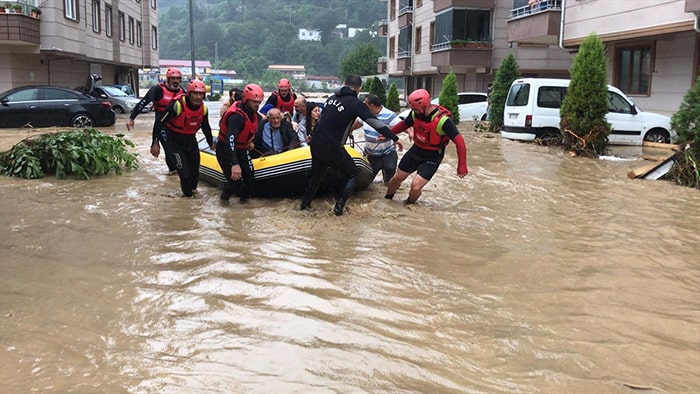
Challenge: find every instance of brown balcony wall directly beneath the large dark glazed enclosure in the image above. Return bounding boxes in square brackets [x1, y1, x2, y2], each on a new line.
[430, 40, 493, 68]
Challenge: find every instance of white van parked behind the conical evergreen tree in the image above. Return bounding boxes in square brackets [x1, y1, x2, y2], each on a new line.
[501, 78, 678, 145]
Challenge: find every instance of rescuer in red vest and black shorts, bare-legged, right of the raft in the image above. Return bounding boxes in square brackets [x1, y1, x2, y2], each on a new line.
[384, 89, 469, 204]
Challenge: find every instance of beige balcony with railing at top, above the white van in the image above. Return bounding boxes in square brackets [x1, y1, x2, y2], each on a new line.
[507, 0, 561, 44]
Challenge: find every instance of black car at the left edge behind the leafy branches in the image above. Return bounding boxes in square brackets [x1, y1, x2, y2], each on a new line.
[0, 86, 116, 127]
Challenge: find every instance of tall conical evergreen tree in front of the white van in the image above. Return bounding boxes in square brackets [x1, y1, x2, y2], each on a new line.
[560, 33, 611, 156]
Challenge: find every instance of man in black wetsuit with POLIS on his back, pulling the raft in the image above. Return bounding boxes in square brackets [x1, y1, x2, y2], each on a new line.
[300, 74, 399, 216]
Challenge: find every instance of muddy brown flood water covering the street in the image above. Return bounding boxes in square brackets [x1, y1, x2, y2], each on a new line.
[0, 111, 700, 393]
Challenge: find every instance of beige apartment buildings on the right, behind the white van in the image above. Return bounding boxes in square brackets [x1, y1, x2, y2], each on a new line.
[377, 0, 700, 115]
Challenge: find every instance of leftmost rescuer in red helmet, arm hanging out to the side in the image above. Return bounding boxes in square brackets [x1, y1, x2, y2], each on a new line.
[126, 68, 185, 175]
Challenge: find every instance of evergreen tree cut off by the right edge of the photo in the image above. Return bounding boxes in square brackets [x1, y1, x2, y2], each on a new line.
[669, 76, 700, 189]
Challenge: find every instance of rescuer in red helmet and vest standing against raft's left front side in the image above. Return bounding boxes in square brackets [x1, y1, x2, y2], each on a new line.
[216, 83, 264, 204]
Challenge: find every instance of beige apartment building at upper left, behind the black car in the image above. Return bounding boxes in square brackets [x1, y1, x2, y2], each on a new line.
[0, 0, 158, 91]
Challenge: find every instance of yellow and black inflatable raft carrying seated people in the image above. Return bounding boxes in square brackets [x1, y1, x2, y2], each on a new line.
[199, 138, 372, 197]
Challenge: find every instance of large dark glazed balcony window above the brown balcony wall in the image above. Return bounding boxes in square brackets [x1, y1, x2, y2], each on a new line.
[435, 9, 491, 45]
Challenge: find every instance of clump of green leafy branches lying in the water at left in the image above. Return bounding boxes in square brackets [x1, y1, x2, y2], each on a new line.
[0, 129, 139, 179]
